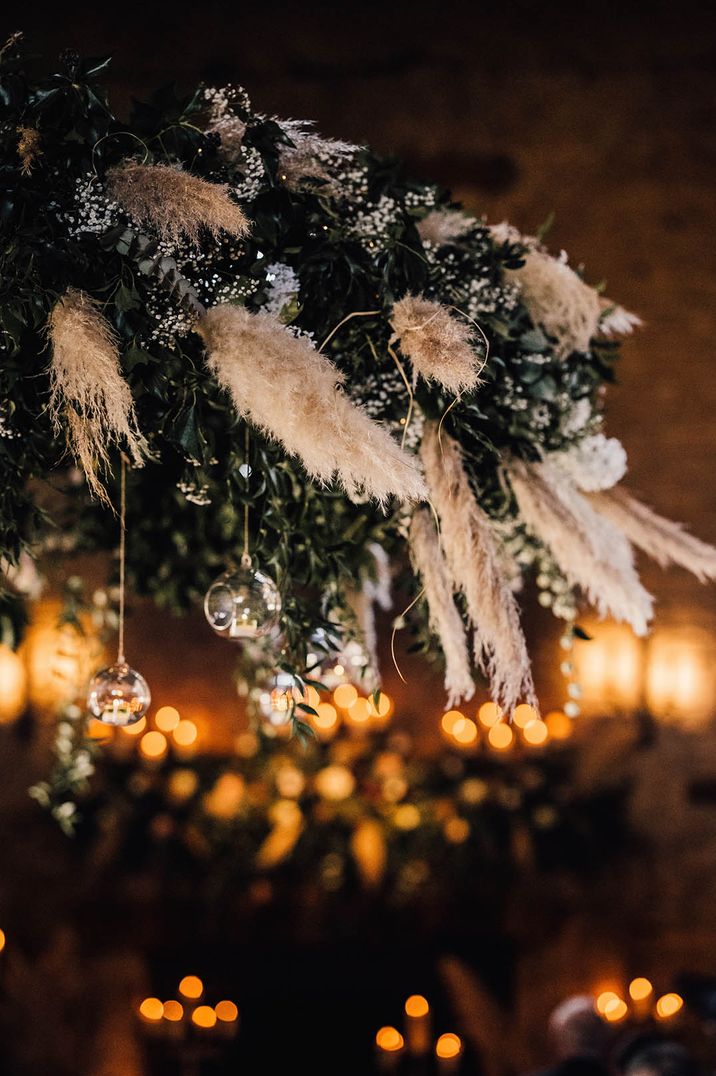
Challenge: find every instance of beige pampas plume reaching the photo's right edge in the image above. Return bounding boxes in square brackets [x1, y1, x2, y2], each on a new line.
[589, 489, 716, 583]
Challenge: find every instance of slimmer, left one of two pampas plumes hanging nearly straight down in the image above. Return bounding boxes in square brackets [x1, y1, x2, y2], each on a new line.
[410, 508, 475, 706]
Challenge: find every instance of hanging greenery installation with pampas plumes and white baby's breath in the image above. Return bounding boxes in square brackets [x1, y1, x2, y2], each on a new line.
[0, 36, 716, 740]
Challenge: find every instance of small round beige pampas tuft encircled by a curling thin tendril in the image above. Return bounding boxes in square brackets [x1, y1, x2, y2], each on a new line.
[390, 295, 481, 395]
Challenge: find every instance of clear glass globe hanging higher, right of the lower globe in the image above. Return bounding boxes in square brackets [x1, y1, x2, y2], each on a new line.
[203, 565, 281, 641]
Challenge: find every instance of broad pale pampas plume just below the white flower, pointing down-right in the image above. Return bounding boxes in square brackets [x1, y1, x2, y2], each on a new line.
[508, 461, 654, 635]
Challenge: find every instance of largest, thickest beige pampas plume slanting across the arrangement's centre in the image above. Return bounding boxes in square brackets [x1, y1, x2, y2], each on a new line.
[197, 305, 424, 504]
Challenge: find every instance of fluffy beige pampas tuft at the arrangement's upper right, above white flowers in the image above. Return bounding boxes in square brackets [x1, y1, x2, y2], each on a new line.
[506, 250, 602, 358]
